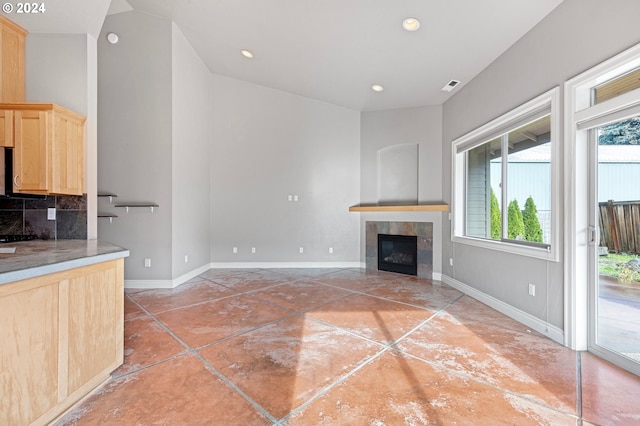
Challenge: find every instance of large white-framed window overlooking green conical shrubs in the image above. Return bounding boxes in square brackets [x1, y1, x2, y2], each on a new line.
[452, 89, 558, 259]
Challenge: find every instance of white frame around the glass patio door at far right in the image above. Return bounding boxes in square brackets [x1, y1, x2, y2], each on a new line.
[564, 44, 640, 374]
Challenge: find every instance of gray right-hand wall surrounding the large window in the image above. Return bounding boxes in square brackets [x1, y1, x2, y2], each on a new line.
[442, 0, 640, 328]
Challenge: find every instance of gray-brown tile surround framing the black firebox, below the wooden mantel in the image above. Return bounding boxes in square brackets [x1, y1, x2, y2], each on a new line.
[365, 221, 433, 279]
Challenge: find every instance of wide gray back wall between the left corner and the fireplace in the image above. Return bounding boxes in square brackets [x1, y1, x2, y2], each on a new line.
[211, 75, 360, 262]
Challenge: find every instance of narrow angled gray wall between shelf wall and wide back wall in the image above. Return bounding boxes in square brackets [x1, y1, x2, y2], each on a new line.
[172, 24, 212, 278]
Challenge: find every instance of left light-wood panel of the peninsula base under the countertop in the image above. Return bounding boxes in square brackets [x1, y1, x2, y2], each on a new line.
[0, 280, 60, 425]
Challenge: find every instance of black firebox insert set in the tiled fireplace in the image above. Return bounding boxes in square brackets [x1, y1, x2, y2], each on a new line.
[378, 234, 418, 275]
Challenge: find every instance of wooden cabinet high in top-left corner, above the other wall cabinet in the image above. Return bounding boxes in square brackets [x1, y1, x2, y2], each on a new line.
[0, 16, 27, 102]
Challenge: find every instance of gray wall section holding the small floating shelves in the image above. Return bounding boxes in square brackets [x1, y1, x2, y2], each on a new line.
[98, 12, 173, 280]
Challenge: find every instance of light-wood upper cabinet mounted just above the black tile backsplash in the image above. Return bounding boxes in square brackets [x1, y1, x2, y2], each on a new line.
[0, 103, 85, 195]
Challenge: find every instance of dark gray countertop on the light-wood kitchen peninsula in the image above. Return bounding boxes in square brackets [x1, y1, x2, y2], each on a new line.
[0, 240, 129, 285]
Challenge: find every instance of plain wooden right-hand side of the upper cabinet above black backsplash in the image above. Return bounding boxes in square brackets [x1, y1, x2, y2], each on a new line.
[50, 113, 84, 195]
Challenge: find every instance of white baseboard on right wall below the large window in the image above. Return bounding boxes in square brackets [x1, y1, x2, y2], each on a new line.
[434, 273, 564, 345]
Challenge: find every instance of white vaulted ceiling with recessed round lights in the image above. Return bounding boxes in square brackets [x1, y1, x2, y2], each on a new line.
[10, 0, 562, 111]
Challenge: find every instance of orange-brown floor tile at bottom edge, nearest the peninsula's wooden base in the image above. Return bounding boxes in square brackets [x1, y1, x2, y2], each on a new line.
[57, 355, 272, 426]
